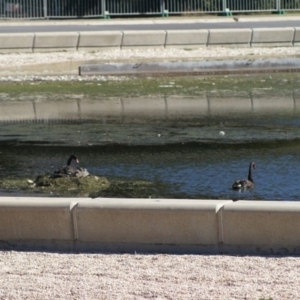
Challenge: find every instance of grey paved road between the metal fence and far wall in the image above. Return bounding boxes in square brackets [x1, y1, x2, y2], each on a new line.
[0, 18, 300, 33]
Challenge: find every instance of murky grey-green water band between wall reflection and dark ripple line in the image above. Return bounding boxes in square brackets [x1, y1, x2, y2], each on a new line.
[0, 112, 300, 146]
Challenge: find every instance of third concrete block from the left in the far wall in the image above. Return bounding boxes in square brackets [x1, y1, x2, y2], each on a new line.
[78, 31, 123, 51]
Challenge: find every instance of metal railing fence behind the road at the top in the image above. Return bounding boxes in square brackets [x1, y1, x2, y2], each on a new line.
[0, 0, 300, 19]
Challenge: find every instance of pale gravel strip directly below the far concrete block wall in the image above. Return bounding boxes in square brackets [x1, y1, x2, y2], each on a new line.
[0, 47, 300, 67]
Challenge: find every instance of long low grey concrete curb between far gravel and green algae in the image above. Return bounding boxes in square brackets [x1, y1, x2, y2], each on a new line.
[79, 58, 300, 75]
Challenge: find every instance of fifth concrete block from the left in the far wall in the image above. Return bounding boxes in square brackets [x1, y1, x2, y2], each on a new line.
[165, 30, 208, 48]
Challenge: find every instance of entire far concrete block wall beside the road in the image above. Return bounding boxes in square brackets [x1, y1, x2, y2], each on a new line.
[0, 27, 300, 53]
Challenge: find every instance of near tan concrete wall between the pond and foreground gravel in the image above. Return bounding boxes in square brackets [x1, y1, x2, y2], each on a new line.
[0, 197, 300, 255]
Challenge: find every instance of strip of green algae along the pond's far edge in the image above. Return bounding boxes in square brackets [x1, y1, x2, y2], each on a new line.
[0, 73, 300, 101]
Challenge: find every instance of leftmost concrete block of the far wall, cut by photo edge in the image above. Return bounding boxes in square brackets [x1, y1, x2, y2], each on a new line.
[0, 33, 34, 53]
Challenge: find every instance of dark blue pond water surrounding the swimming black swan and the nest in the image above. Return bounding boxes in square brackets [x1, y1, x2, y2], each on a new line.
[0, 99, 300, 201]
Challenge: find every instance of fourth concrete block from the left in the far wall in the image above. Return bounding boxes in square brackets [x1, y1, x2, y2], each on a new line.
[122, 30, 167, 48]
